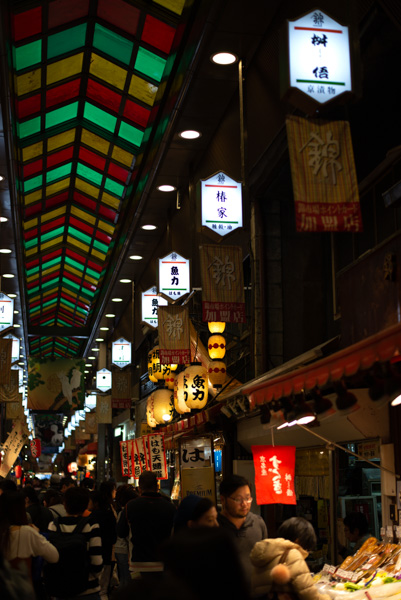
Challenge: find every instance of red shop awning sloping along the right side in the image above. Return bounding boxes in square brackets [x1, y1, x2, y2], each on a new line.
[229, 323, 401, 407]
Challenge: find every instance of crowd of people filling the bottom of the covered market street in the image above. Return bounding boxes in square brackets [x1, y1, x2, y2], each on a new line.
[0, 471, 364, 600]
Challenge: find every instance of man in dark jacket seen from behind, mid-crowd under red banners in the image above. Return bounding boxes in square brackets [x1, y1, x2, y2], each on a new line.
[117, 471, 175, 575]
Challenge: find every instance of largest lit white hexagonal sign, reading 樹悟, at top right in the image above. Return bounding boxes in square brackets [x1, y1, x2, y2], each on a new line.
[287, 9, 352, 109]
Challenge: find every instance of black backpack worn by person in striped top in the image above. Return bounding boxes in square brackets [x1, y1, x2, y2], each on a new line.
[43, 518, 90, 598]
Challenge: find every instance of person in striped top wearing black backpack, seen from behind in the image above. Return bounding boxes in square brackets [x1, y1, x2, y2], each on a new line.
[44, 486, 103, 600]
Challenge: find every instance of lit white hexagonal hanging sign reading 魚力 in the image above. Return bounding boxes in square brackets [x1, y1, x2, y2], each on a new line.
[159, 252, 191, 300]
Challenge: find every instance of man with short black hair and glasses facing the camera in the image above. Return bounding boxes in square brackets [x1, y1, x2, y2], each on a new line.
[217, 475, 267, 581]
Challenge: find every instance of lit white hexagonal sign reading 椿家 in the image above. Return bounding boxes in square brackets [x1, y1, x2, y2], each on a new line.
[201, 171, 242, 235]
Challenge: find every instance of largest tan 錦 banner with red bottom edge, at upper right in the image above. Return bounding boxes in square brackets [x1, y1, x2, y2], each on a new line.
[286, 116, 362, 232]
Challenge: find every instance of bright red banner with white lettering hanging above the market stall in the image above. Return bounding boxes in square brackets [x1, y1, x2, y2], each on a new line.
[251, 446, 297, 505]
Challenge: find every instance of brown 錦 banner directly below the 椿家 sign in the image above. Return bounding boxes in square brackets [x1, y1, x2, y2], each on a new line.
[200, 244, 245, 323]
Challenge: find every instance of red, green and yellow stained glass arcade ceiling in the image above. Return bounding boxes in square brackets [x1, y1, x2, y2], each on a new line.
[8, 0, 191, 357]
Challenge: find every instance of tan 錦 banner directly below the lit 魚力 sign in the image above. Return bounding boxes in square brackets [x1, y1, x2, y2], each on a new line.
[158, 306, 191, 365]
